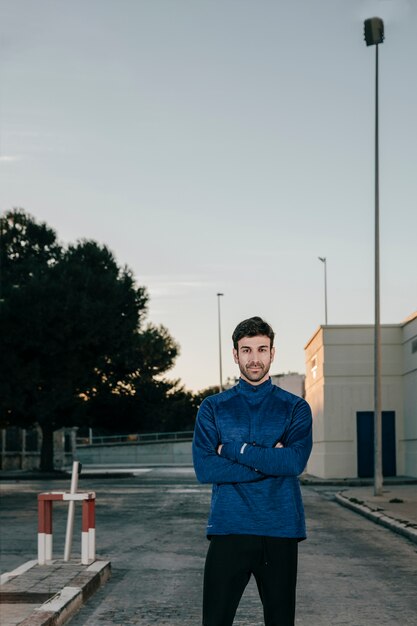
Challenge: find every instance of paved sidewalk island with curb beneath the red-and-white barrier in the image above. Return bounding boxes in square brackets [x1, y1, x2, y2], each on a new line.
[0, 560, 111, 626]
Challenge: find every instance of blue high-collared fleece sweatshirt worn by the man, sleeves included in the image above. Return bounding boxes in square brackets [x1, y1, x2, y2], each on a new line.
[193, 379, 312, 539]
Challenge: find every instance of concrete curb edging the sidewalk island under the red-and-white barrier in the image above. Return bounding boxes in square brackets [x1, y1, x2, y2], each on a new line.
[3, 561, 111, 626]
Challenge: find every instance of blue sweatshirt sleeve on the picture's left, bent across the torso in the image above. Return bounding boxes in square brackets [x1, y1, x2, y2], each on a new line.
[193, 398, 264, 484]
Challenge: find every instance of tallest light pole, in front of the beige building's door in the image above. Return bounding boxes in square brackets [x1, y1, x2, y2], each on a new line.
[364, 17, 384, 496]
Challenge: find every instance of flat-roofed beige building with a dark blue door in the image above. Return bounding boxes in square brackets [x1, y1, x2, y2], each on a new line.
[305, 312, 417, 478]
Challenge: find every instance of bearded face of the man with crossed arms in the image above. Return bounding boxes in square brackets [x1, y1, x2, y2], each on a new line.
[233, 335, 275, 385]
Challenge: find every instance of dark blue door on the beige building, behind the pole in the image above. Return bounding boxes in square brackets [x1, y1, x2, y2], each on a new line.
[356, 411, 397, 478]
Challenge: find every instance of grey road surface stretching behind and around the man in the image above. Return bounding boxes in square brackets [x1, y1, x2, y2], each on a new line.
[0, 468, 417, 626]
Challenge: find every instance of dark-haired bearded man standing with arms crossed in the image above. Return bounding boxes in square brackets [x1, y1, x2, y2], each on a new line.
[193, 317, 312, 626]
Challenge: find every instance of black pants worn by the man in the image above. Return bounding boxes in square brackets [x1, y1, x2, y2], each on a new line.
[203, 535, 298, 626]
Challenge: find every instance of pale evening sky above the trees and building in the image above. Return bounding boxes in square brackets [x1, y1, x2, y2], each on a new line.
[0, 0, 417, 391]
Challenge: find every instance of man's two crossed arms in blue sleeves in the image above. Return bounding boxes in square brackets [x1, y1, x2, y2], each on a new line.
[193, 394, 312, 483]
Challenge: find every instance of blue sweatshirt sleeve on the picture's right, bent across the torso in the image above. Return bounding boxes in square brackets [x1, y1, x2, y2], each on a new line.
[221, 400, 313, 476]
